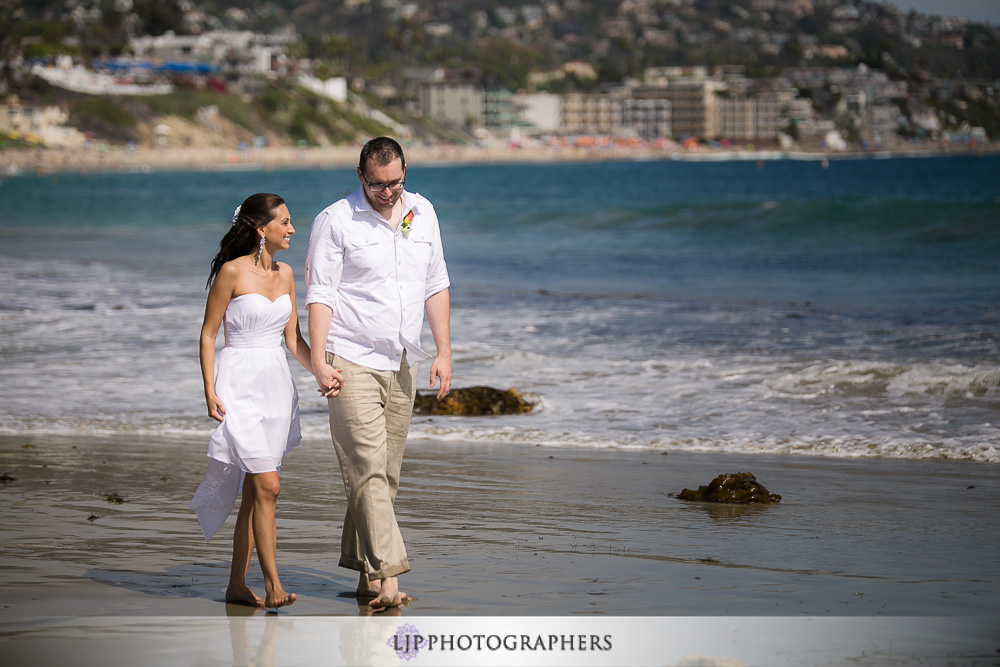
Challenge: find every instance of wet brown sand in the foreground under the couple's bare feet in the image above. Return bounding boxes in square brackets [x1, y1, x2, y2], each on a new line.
[0, 430, 1000, 664]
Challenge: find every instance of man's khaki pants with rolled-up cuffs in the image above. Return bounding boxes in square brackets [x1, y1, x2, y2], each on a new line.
[326, 352, 417, 580]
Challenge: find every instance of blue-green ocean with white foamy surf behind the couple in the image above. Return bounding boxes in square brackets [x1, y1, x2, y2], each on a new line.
[0, 155, 1000, 463]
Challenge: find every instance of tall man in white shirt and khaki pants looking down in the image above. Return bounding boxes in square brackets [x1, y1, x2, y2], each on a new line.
[306, 137, 451, 609]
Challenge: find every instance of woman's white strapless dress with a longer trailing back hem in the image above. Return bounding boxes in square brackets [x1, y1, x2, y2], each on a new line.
[188, 294, 302, 540]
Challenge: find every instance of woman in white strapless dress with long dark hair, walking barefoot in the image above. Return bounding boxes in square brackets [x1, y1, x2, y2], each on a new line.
[189, 193, 328, 608]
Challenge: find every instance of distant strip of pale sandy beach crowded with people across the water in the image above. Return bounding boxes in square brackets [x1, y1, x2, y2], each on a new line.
[0, 144, 1000, 176]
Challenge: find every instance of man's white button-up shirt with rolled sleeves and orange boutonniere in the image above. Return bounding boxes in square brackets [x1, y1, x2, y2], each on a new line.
[305, 186, 450, 371]
